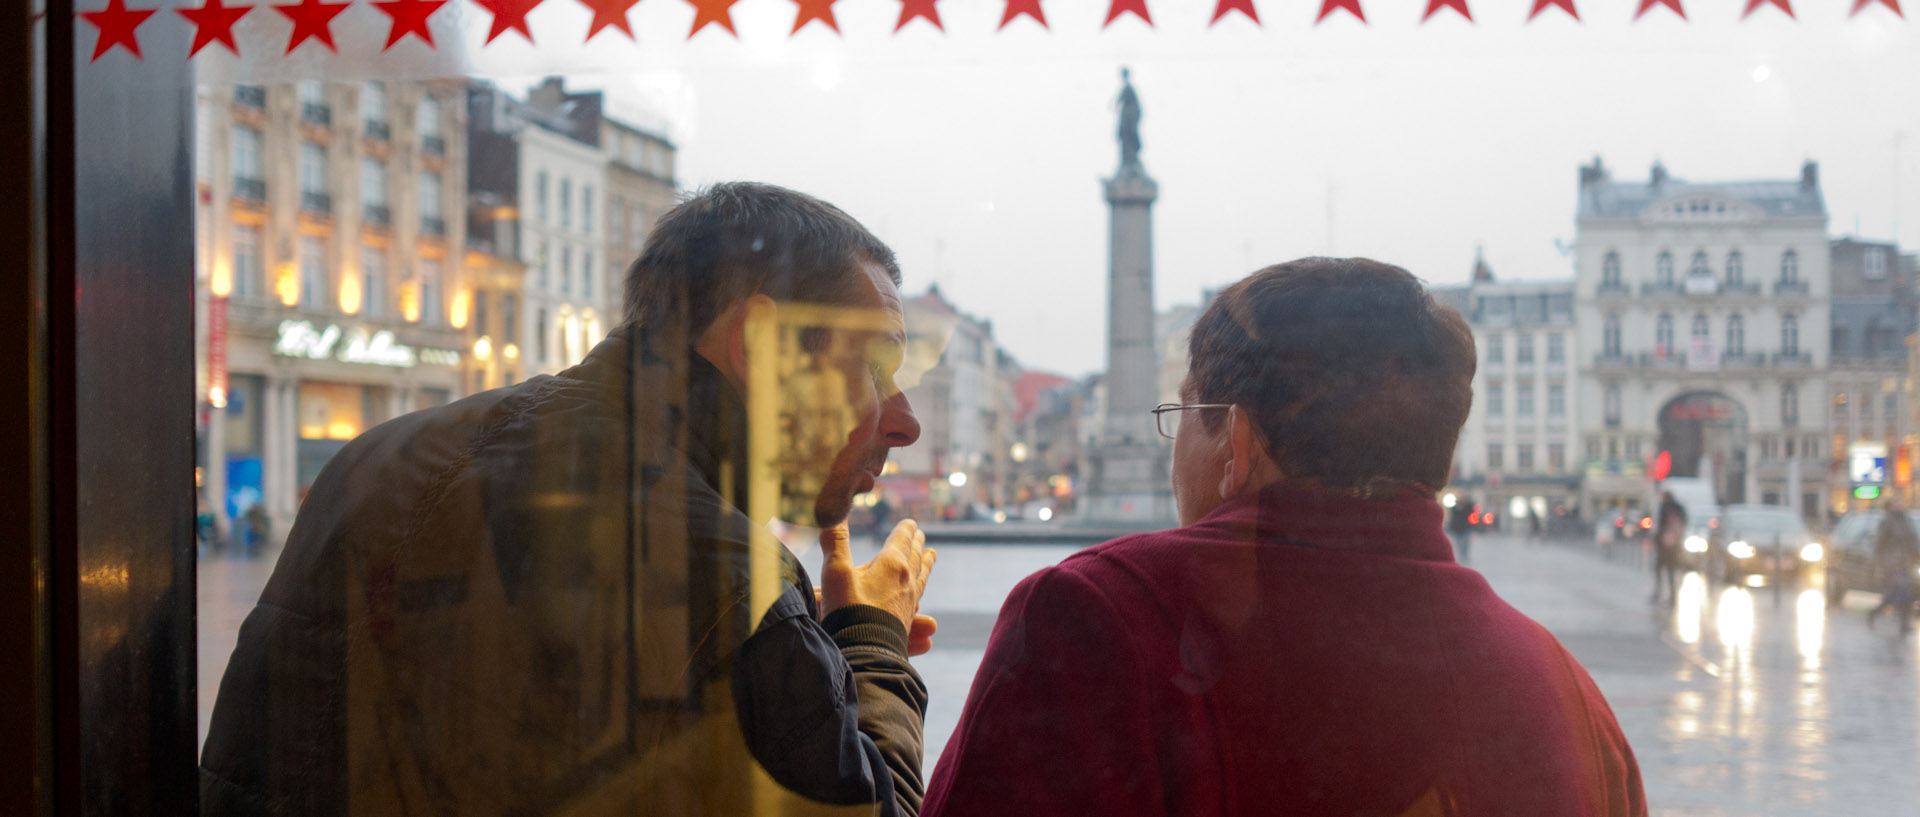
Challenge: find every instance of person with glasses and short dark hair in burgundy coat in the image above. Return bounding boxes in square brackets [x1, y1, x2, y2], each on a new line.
[925, 259, 1647, 817]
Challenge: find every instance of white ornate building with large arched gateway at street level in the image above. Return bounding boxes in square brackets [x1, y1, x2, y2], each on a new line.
[1574, 159, 1830, 516]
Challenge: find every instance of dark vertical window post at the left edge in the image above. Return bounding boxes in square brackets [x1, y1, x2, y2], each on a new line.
[44, 0, 198, 815]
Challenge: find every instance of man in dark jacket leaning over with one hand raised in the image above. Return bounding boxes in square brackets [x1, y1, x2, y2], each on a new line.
[202, 184, 935, 817]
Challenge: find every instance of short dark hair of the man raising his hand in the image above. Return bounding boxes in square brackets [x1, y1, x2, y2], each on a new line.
[624, 182, 900, 336]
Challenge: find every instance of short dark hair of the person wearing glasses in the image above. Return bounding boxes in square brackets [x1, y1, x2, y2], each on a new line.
[1188, 259, 1476, 487]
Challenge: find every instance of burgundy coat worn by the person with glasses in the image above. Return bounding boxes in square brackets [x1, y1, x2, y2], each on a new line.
[922, 489, 1647, 817]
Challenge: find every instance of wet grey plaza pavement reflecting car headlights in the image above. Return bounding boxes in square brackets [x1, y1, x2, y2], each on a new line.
[200, 535, 1920, 817]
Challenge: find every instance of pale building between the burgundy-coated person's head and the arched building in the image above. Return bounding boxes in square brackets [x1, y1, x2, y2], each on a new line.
[1434, 251, 1582, 529]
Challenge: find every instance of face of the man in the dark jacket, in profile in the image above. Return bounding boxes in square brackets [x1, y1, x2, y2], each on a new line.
[781, 263, 920, 527]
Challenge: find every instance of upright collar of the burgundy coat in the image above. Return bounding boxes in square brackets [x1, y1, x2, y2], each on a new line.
[1192, 483, 1453, 562]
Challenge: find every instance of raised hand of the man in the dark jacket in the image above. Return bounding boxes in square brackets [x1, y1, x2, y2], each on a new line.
[820, 520, 939, 656]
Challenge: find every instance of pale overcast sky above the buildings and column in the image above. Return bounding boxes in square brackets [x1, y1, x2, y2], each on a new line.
[250, 0, 1920, 374]
